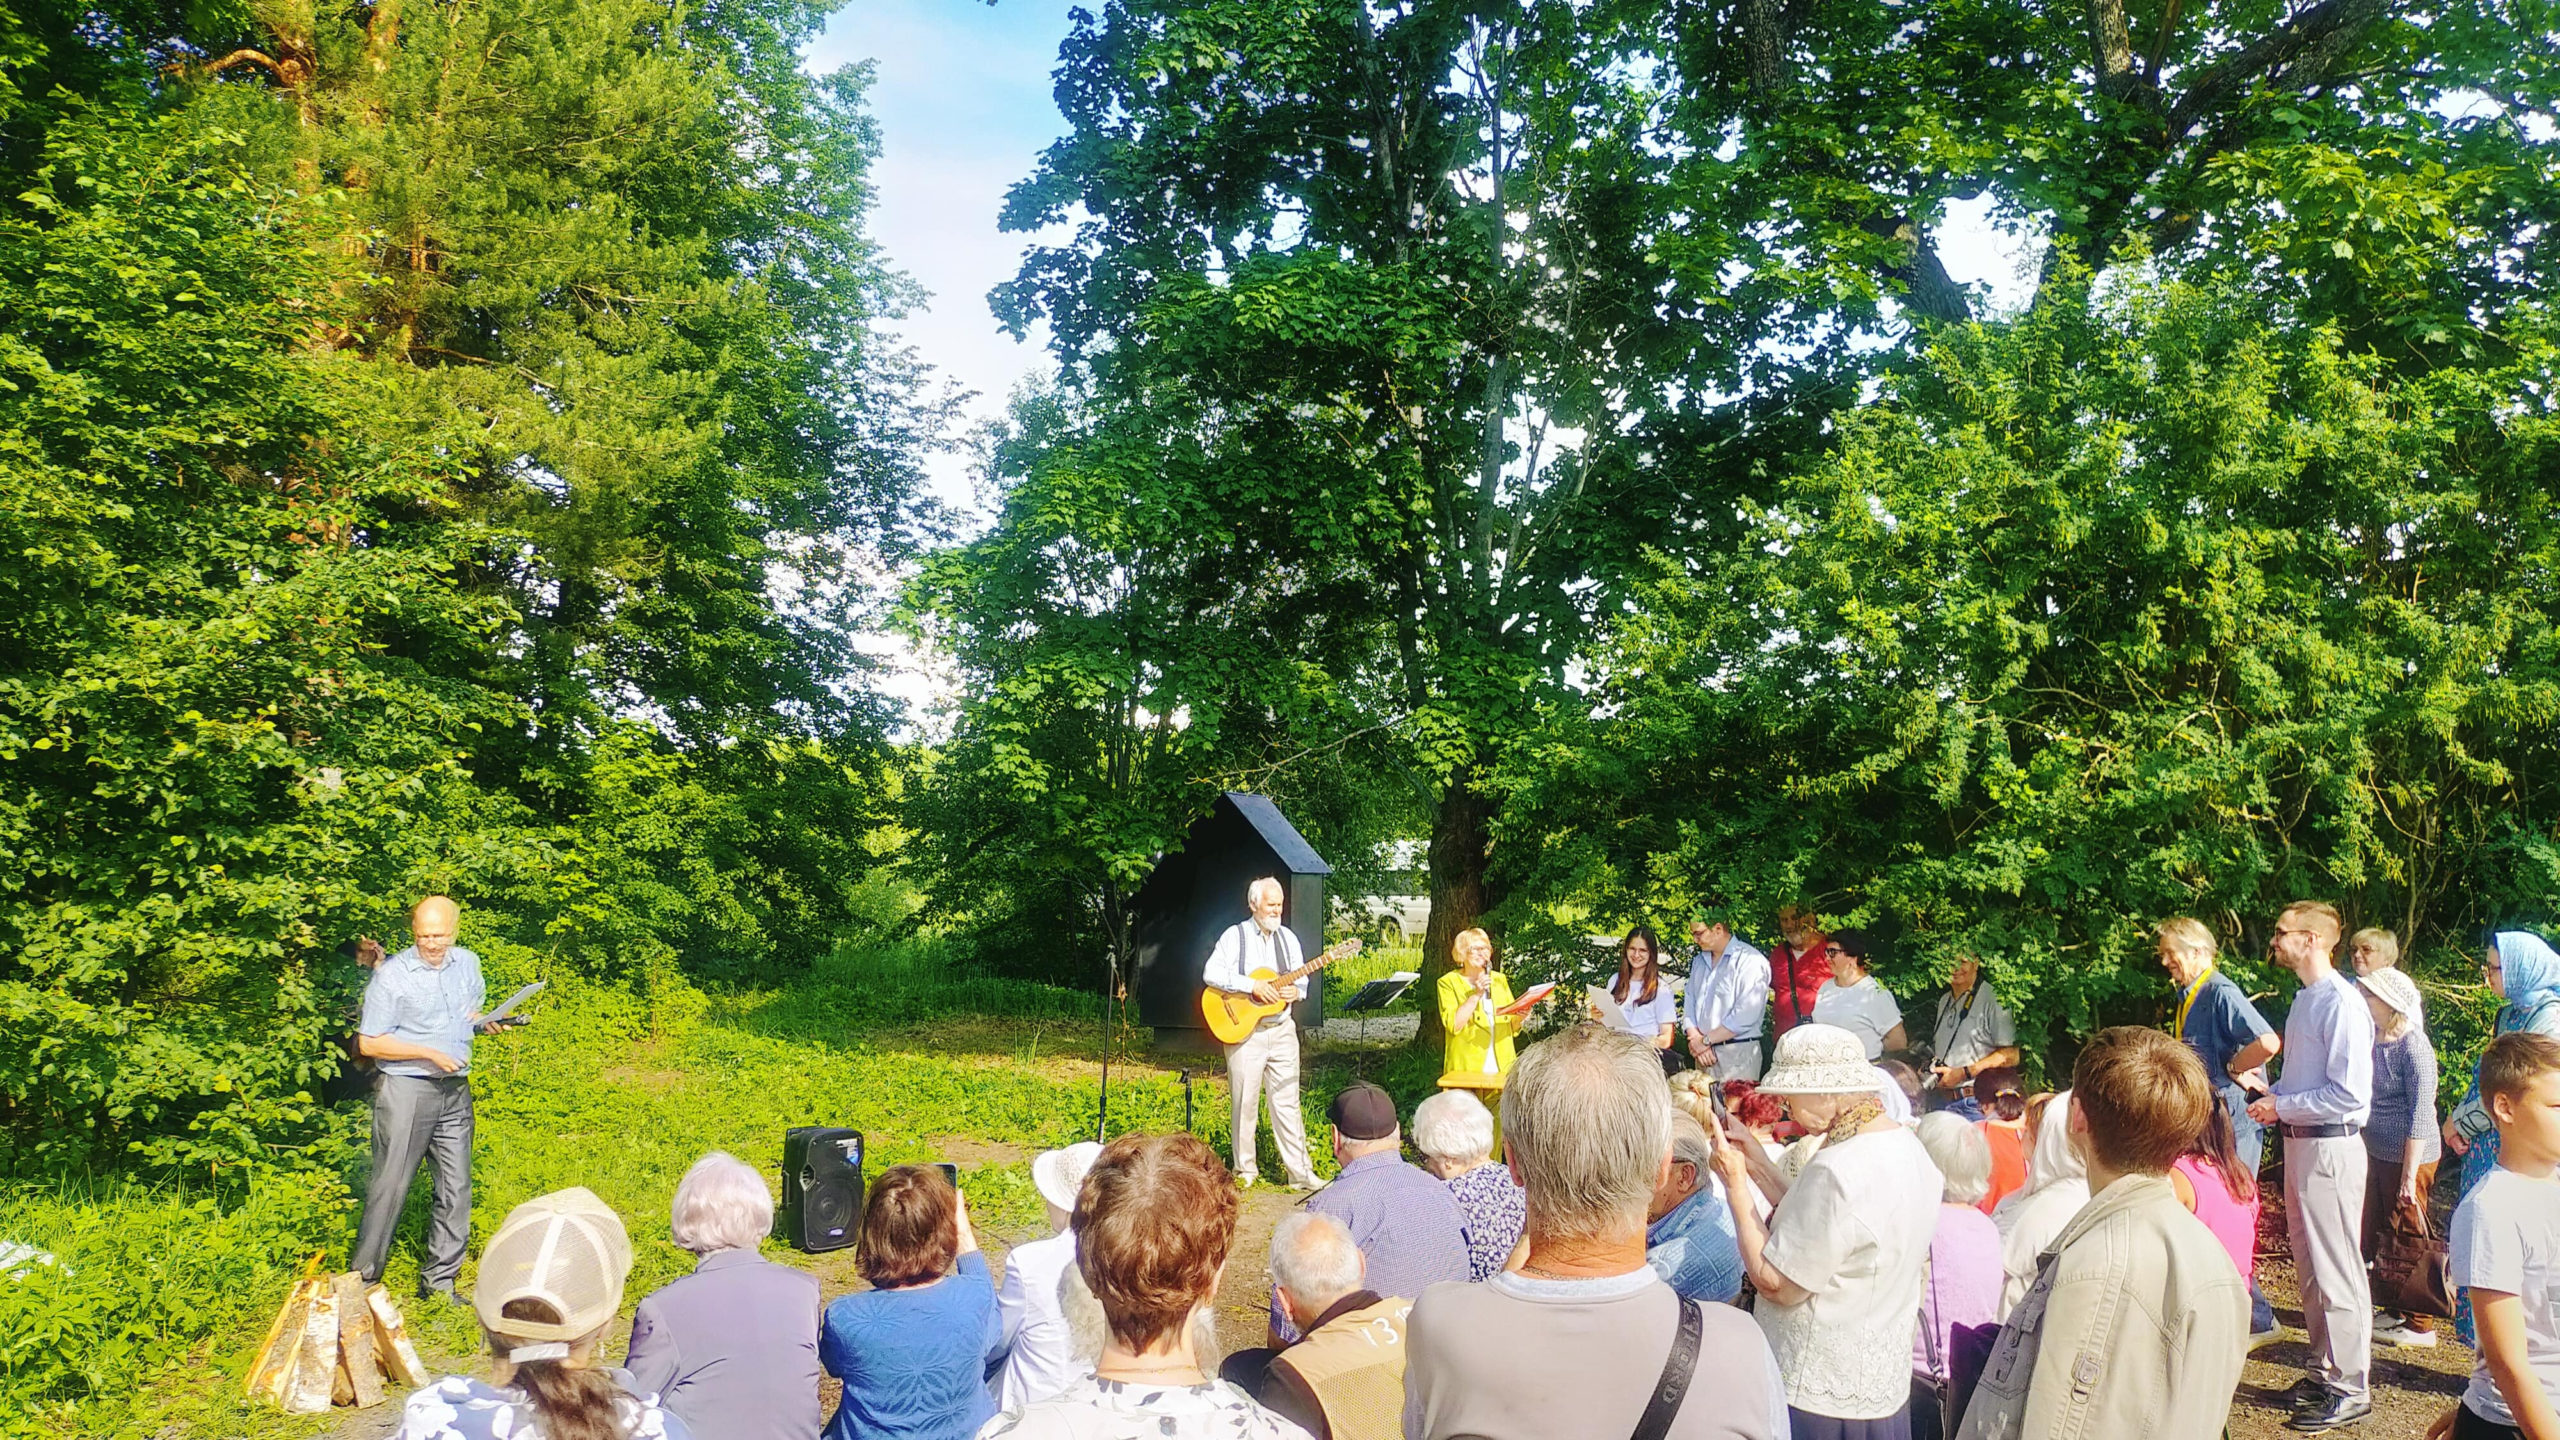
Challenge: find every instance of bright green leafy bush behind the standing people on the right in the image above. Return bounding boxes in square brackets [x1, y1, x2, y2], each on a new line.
[1505, 269, 2560, 1035]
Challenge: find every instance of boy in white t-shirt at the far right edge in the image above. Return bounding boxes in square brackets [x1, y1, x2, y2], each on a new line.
[2427, 1030, 2560, 1440]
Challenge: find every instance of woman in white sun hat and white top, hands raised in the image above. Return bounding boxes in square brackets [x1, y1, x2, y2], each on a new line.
[1715, 1022, 1946, 1440]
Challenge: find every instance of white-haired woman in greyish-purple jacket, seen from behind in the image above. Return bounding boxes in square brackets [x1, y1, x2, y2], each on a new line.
[627, 1150, 824, 1440]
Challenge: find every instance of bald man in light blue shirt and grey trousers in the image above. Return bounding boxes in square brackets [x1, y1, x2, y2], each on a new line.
[353, 894, 509, 1299]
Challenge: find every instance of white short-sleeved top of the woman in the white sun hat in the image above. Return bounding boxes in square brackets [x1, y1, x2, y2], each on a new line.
[1751, 1130, 1946, 1420]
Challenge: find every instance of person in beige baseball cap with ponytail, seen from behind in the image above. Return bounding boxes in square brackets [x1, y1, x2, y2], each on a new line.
[399, 1189, 691, 1440]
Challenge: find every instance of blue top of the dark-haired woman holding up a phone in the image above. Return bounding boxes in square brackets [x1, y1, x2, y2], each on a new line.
[817, 1250, 996, 1440]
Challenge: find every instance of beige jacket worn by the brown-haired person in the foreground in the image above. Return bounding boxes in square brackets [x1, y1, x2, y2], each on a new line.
[1956, 1176, 2248, 1440]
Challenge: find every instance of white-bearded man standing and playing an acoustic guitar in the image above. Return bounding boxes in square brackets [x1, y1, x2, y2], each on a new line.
[1201, 876, 1359, 1189]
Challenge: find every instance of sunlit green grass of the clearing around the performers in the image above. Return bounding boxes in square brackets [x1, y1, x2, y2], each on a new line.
[0, 943, 1439, 1440]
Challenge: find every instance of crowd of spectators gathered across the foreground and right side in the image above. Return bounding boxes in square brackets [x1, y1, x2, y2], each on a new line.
[366, 902, 2560, 1440]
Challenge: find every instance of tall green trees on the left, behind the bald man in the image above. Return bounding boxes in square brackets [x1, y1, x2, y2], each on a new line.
[0, 0, 934, 1176]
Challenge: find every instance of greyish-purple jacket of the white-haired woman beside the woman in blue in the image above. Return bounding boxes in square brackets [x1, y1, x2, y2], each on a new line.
[625, 1250, 824, 1440]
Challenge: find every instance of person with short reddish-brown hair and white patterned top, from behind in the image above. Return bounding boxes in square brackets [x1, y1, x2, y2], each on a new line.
[978, 1135, 1306, 1440]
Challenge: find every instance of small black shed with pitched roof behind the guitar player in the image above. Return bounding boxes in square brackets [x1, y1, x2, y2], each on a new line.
[1134, 789, 1334, 1045]
